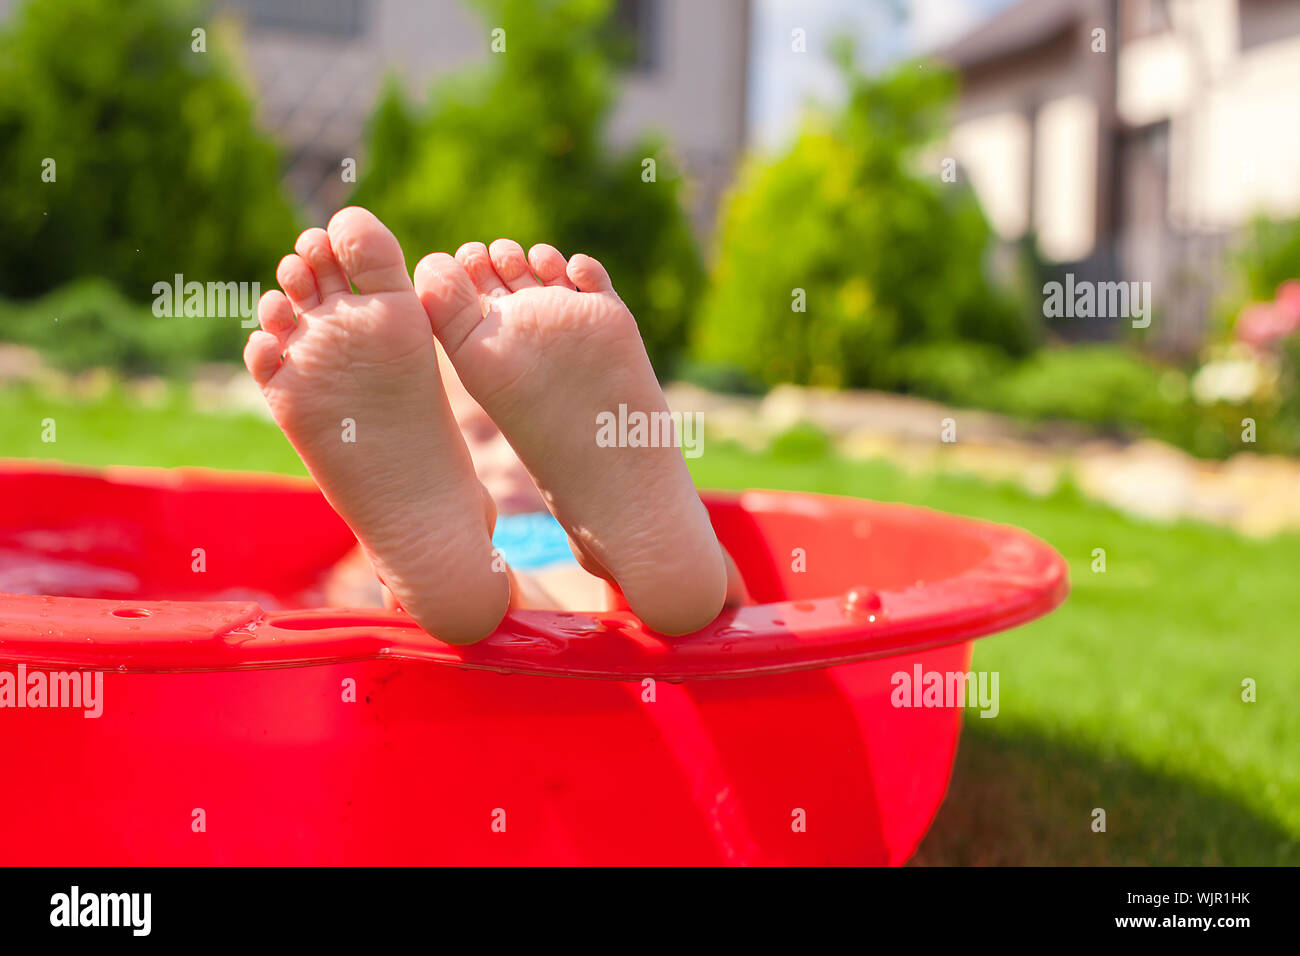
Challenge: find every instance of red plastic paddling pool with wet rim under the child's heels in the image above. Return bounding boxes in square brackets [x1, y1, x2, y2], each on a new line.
[0, 463, 1069, 865]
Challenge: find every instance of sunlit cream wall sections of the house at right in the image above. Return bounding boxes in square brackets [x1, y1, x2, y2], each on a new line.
[950, 0, 1300, 251]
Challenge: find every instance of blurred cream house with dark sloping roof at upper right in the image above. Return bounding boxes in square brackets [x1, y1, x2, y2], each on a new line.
[939, 0, 1300, 354]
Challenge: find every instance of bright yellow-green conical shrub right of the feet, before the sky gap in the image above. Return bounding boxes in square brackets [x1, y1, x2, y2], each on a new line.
[694, 55, 1035, 388]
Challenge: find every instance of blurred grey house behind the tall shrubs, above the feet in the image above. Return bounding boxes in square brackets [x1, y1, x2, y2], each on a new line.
[220, 0, 750, 235]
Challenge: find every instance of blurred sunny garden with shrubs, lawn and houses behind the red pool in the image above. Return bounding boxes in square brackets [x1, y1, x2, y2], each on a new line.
[0, 0, 1300, 864]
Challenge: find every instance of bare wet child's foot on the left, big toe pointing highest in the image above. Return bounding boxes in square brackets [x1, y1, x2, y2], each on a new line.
[244, 207, 510, 644]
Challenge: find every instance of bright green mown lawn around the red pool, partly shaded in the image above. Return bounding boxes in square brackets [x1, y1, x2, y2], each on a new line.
[0, 388, 1300, 865]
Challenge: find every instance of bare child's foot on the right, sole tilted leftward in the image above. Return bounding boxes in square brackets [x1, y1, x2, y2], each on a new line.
[415, 239, 727, 633]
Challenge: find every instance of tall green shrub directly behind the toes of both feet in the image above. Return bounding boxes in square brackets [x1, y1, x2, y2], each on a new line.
[354, 0, 703, 375]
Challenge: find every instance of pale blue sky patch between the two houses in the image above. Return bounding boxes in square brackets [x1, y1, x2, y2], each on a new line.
[749, 0, 1011, 147]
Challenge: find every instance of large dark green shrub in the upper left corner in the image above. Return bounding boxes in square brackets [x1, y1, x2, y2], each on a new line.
[0, 0, 295, 303]
